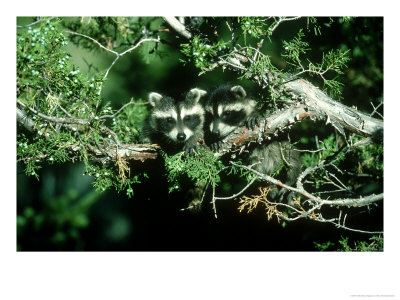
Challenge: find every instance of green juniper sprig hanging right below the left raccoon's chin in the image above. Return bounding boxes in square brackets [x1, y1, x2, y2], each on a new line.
[163, 149, 223, 192]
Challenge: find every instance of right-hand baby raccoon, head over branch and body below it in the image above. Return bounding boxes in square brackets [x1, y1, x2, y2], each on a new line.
[205, 85, 301, 200]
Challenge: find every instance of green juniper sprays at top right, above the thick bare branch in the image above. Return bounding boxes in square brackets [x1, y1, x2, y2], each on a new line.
[181, 17, 352, 103]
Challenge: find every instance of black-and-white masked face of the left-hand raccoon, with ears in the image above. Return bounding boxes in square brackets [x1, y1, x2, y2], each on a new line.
[149, 89, 205, 143]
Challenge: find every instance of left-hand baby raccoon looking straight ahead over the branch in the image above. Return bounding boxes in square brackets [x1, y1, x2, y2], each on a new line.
[141, 88, 206, 155]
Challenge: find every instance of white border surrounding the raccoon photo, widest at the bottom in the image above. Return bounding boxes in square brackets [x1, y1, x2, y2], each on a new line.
[0, 0, 400, 300]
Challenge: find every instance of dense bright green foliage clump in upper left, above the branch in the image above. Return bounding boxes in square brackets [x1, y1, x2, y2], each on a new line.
[17, 19, 101, 107]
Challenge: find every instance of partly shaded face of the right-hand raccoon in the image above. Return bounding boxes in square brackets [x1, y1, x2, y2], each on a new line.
[206, 85, 255, 139]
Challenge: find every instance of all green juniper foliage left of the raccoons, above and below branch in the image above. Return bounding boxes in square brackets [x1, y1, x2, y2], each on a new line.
[17, 18, 147, 196]
